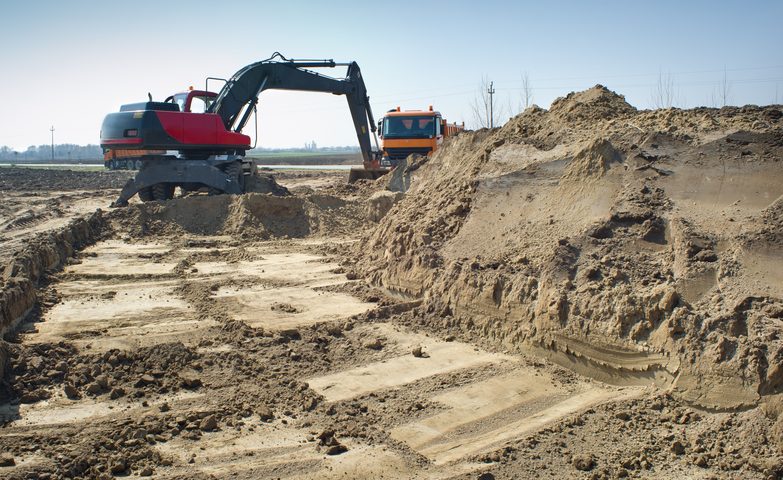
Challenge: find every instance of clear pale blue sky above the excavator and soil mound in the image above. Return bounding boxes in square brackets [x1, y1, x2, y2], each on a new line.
[0, 0, 783, 149]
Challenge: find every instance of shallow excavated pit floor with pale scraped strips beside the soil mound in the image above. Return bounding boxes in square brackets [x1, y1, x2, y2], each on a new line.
[0, 189, 642, 478]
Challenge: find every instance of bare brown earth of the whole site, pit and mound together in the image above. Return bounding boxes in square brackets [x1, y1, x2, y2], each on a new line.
[0, 92, 783, 479]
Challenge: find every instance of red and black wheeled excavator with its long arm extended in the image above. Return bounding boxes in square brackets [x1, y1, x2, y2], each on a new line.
[101, 52, 388, 206]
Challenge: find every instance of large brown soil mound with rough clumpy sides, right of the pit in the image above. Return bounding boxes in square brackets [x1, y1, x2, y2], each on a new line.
[354, 86, 783, 410]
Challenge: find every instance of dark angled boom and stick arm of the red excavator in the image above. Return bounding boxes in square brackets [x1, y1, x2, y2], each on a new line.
[209, 53, 378, 164]
